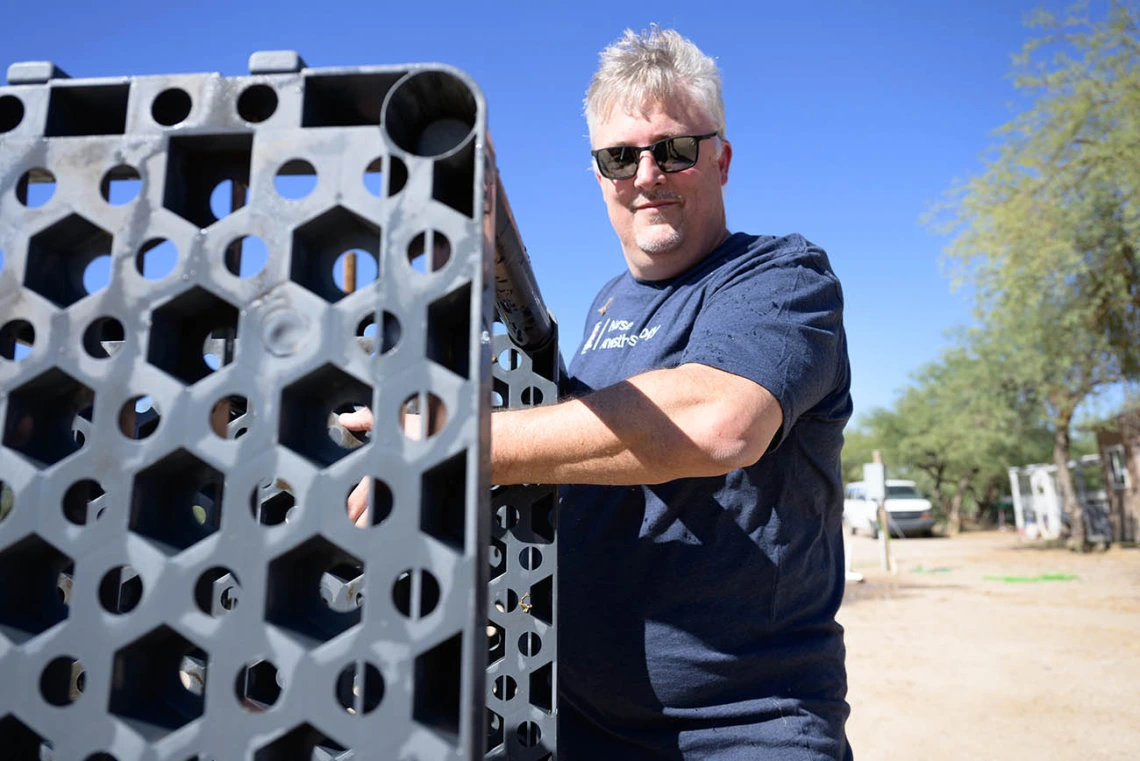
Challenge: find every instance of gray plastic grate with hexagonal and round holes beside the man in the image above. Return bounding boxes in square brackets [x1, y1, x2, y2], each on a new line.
[0, 58, 556, 761]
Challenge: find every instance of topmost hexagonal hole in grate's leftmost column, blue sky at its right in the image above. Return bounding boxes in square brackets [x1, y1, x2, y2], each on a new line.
[24, 214, 112, 306]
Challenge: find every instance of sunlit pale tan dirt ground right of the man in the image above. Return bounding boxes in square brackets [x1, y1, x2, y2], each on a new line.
[839, 532, 1140, 761]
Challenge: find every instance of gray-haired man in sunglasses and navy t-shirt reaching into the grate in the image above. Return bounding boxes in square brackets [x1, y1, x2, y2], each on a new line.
[342, 27, 850, 761]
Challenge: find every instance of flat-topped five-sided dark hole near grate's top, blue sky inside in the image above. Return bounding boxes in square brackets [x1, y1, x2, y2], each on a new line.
[162, 133, 253, 228]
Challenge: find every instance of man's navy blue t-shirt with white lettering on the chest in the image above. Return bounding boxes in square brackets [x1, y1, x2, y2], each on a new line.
[559, 234, 852, 761]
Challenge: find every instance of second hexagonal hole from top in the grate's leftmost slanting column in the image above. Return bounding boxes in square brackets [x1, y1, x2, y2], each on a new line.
[3, 368, 95, 467]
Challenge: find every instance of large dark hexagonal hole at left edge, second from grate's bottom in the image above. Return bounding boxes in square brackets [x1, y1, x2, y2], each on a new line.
[0, 534, 74, 643]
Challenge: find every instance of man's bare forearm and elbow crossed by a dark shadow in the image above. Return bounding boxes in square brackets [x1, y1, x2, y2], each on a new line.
[491, 363, 783, 484]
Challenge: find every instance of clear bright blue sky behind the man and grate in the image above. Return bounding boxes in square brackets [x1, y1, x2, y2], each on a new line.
[0, 0, 1059, 414]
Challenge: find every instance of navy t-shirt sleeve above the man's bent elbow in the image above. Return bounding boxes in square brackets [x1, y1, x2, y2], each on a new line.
[682, 244, 846, 448]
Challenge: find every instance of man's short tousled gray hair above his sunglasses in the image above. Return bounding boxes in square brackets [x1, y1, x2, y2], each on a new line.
[585, 24, 725, 140]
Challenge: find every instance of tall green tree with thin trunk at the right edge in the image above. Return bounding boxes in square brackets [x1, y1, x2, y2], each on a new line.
[943, 1, 1140, 549]
